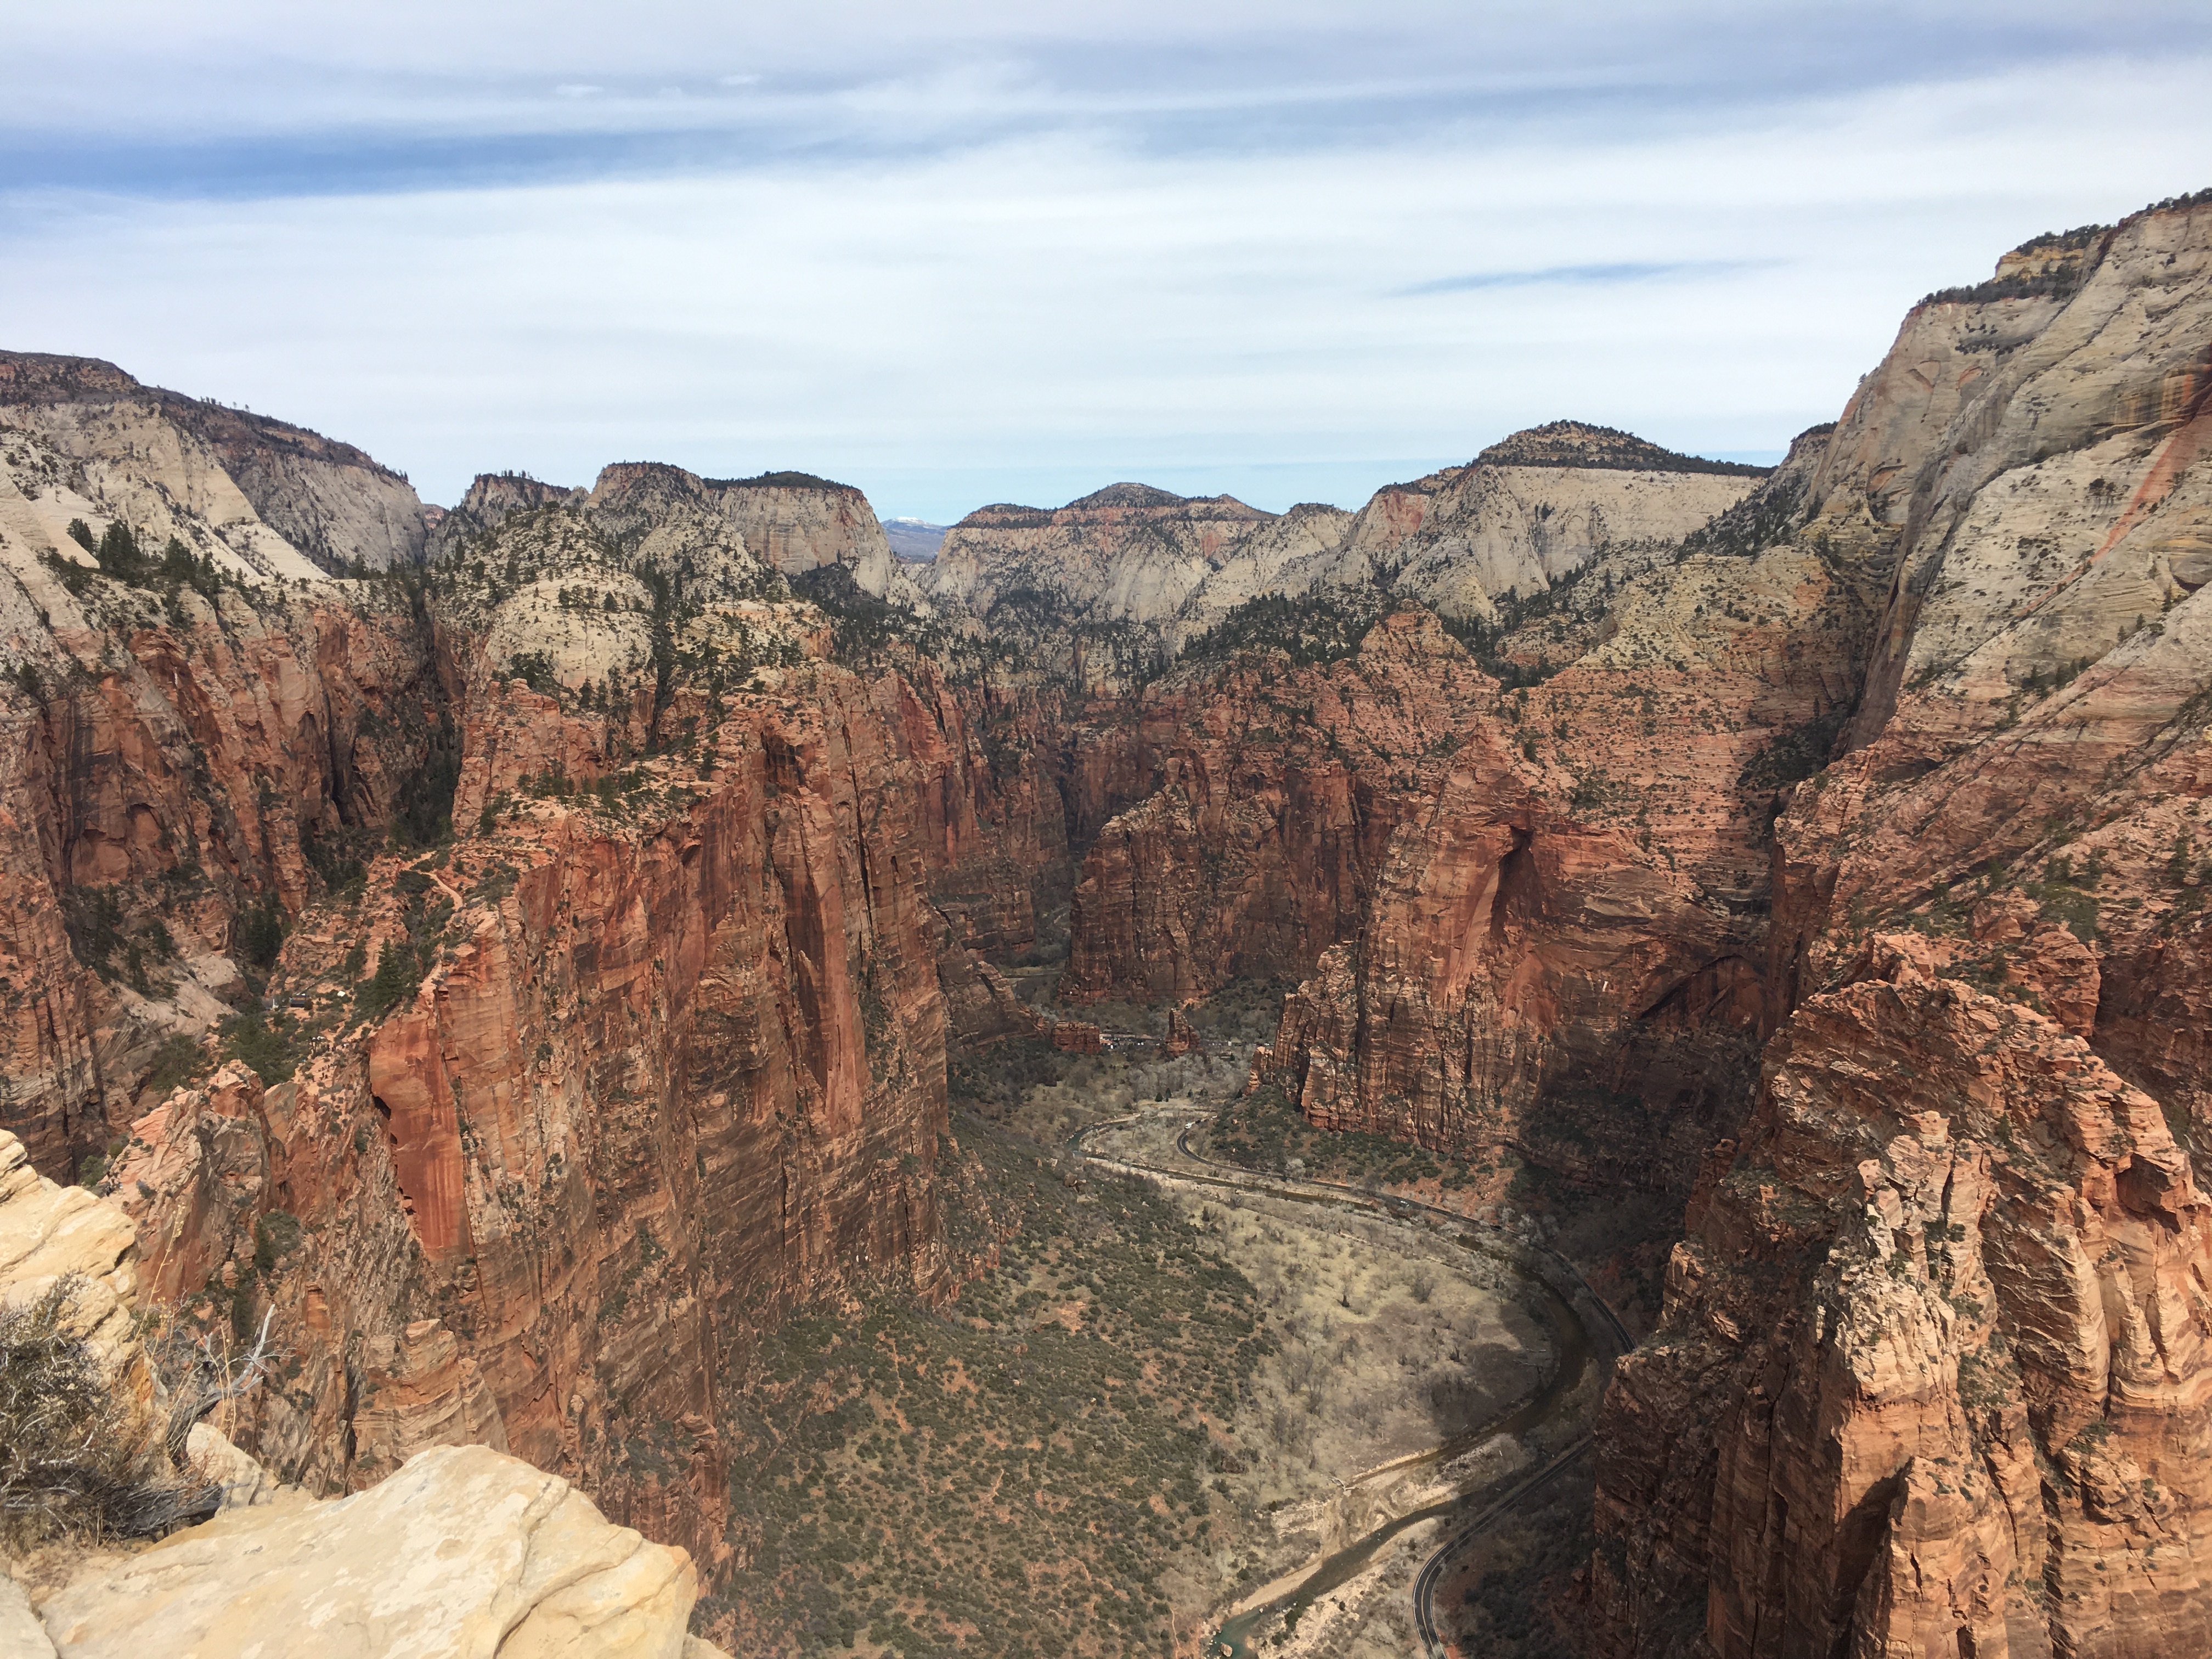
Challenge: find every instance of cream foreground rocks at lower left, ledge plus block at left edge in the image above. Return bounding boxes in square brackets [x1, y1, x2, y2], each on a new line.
[0, 1124, 703, 1659]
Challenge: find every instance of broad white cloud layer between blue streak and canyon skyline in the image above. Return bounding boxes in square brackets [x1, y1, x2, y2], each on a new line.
[0, 13, 2212, 522]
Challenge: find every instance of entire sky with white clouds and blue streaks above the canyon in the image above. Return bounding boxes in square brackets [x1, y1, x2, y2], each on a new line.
[0, 0, 2212, 522]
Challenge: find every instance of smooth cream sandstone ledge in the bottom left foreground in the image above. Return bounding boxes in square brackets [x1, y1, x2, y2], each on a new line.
[40, 1447, 714, 1659]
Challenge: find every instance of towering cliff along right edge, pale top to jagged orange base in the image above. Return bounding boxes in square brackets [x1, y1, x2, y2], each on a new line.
[1593, 191, 2212, 1657]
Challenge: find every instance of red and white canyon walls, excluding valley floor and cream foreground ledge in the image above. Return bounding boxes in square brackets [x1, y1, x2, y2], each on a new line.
[0, 184, 2212, 1659]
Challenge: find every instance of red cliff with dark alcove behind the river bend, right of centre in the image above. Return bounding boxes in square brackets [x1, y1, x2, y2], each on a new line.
[1062, 436, 1884, 1186]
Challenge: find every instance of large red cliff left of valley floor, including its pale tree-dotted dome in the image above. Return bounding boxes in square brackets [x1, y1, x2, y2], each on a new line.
[52, 479, 1064, 1571]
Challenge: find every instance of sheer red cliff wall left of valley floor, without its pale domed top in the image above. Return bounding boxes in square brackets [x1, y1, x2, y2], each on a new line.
[124, 668, 945, 1562]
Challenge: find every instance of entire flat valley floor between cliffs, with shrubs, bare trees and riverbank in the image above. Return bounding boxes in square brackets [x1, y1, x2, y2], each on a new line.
[699, 986, 1654, 1659]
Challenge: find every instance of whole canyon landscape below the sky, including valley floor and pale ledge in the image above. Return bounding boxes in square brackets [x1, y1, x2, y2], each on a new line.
[0, 193, 2212, 1659]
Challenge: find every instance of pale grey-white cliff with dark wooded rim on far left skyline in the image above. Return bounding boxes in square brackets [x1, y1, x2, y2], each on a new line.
[0, 352, 429, 575]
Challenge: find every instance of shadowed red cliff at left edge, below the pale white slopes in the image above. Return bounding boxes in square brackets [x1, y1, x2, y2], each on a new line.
[0, 544, 442, 1172]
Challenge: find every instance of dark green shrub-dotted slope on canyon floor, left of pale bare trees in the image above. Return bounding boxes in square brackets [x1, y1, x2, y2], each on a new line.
[708, 1117, 1272, 1659]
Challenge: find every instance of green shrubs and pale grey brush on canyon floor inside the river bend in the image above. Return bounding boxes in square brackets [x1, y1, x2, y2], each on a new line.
[706, 1000, 1542, 1659]
